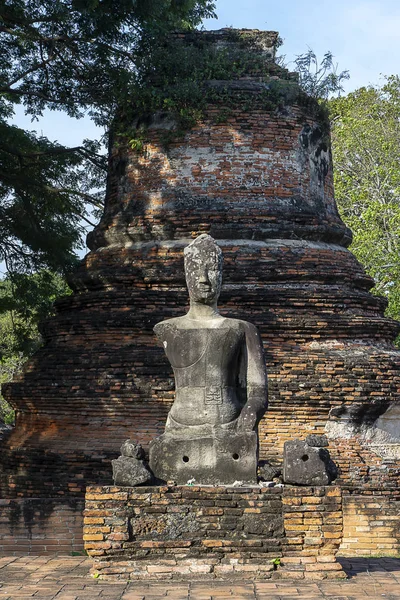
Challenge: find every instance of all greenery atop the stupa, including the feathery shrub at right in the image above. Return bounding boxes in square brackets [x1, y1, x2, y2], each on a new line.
[122, 41, 349, 152]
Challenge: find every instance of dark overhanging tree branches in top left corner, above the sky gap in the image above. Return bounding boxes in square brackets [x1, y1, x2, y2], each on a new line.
[0, 0, 214, 126]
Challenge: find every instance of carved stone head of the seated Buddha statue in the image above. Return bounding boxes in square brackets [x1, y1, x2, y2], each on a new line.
[184, 234, 223, 306]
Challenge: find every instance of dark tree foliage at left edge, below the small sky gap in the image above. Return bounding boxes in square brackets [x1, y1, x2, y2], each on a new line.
[0, 119, 105, 273]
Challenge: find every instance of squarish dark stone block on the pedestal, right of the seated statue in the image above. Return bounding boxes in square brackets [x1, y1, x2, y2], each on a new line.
[283, 440, 337, 485]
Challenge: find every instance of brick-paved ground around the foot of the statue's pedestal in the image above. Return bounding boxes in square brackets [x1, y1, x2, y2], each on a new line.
[0, 556, 400, 600]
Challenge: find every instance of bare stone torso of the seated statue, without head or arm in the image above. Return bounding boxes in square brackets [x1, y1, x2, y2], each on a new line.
[156, 319, 245, 426]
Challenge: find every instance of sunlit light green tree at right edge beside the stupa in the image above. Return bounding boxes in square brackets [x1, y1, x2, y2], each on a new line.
[329, 76, 400, 319]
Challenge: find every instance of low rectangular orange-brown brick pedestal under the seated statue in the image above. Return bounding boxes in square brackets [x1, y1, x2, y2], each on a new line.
[84, 486, 345, 580]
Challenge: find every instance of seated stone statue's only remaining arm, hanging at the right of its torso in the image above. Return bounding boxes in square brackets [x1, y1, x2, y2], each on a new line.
[238, 322, 268, 431]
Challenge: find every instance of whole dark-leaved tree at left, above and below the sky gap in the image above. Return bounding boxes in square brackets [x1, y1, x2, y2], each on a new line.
[0, 0, 213, 272]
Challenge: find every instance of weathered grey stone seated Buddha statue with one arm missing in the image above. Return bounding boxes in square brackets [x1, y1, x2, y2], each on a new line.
[150, 235, 267, 485]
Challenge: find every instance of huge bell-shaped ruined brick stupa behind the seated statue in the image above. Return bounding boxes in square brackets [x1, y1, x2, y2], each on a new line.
[1, 30, 400, 552]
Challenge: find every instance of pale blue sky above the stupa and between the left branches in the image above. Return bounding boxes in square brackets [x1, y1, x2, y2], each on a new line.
[15, 0, 400, 145]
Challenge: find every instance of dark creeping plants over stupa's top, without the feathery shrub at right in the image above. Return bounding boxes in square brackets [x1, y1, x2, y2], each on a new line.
[120, 30, 302, 152]
